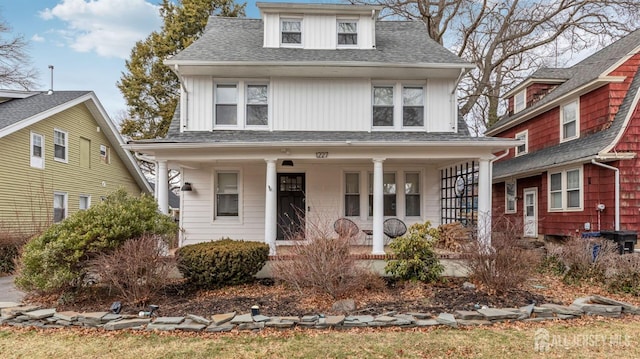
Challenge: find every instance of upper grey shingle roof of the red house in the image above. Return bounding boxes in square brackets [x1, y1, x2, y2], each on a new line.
[487, 29, 640, 131]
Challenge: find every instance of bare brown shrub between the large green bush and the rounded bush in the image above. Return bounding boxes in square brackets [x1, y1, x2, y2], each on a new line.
[89, 235, 174, 305]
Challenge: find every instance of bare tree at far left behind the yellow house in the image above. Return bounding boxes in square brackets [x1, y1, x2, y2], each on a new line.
[0, 17, 38, 90]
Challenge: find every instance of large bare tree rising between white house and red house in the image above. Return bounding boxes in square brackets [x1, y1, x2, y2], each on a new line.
[351, 0, 640, 133]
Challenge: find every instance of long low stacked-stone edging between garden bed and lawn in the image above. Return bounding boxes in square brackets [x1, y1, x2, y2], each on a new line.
[0, 295, 640, 332]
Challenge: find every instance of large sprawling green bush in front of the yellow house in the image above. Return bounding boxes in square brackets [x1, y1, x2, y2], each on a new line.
[15, 189, 177, 292]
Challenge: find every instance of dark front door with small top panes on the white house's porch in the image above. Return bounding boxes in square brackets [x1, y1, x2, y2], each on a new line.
[277, 173, 306, 240]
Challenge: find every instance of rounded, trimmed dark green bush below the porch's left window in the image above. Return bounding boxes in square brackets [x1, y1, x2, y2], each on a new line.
[176, 239, 269, 288]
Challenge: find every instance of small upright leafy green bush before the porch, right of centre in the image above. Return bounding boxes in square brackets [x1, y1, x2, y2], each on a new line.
[385, 222, 444, 282]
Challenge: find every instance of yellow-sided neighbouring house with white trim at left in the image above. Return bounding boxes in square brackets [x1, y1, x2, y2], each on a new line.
[0, 89, 152, 234]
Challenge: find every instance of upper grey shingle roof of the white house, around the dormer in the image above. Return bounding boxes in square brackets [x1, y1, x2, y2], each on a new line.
[169, 16, 467, 64]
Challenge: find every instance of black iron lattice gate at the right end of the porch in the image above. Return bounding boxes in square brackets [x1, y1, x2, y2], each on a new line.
[440, 161, 478, 226]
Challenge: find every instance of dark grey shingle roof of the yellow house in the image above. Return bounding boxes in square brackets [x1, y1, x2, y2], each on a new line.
[0, 91, 91, 129]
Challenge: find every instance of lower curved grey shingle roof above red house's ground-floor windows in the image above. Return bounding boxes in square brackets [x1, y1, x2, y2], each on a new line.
[493, 65, 640, 178]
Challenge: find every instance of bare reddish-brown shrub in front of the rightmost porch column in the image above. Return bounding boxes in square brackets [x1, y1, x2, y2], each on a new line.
[467, 217, 540, 294]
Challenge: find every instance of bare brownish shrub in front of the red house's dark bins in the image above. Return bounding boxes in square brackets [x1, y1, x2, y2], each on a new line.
[547, 237, 620, 283]
